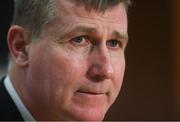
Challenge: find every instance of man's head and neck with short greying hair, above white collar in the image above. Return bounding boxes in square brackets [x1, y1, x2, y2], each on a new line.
[8, 0, 129, 120]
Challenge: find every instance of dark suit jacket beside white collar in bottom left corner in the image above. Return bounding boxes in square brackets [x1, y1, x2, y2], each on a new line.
[0, 78, 23, 121]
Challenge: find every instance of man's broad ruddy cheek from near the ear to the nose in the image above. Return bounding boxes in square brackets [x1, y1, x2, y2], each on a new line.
[28, 45, 86, 111]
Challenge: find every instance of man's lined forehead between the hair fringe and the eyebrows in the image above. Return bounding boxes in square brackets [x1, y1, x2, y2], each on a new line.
[47, 0, 127, 41]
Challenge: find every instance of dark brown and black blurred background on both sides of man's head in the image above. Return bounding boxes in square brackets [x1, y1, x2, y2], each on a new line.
[0, 0, 180, 120]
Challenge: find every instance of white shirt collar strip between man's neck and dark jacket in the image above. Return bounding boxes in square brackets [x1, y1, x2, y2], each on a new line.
[4, 76, 35, 121]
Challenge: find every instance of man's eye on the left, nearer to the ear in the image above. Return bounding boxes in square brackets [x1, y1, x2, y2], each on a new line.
[70, 36, 89, 46]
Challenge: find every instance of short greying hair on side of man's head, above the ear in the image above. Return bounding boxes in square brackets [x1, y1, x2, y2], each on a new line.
[12, 0, 54, 37]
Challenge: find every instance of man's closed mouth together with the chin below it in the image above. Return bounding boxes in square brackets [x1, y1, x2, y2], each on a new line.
[72, 89, 109, 120]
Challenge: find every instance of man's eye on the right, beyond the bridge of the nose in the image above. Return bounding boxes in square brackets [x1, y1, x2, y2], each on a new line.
[107, 39, 122, 49]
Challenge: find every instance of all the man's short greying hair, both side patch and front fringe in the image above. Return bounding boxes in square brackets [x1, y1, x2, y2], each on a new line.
[12, 0, 130, 38]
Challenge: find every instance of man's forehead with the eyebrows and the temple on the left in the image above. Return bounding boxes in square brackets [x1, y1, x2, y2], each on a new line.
[43, 0, 127, 38]
